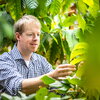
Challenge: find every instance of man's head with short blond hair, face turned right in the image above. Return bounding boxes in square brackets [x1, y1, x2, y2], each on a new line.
[14, 15, 41, 52]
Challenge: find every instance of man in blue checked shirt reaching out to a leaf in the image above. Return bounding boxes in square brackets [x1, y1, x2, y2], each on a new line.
[0, 15, 75, 95]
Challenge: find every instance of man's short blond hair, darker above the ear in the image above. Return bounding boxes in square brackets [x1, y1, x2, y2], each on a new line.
[14, 15, 41, 34]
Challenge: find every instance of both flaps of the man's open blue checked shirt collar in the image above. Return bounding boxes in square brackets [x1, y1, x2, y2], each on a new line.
[11, 44, 38, 61]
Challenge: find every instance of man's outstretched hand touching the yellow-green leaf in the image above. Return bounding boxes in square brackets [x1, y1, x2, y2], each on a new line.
[49, 64, 76, 79]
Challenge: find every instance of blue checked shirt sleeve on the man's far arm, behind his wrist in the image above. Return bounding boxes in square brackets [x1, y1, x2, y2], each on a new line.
[41, 57, 54, 74]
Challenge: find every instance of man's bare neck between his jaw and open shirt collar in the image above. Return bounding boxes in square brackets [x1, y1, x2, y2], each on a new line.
[17, 45, 32, 60]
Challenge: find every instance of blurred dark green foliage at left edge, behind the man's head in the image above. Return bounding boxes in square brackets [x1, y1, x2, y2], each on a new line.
[0, 12, 14, 51]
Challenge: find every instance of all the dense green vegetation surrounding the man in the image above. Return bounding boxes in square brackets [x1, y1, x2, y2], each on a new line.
[0, 0, 100, 100]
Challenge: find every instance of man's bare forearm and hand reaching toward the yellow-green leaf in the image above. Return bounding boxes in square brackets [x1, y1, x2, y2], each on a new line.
[22, 64, 75, 94]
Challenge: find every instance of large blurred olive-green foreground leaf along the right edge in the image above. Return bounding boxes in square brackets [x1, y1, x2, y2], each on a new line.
[81, 14, 100, 100]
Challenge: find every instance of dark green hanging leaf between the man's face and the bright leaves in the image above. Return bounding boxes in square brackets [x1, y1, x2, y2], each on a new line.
[46, 33, 64, 64]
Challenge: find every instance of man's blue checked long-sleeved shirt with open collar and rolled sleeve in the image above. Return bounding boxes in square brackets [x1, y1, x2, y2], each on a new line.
[0, 45, 53, 95]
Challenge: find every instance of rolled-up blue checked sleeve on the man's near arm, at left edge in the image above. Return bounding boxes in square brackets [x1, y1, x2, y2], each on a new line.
[0, 61, 23, 95]
